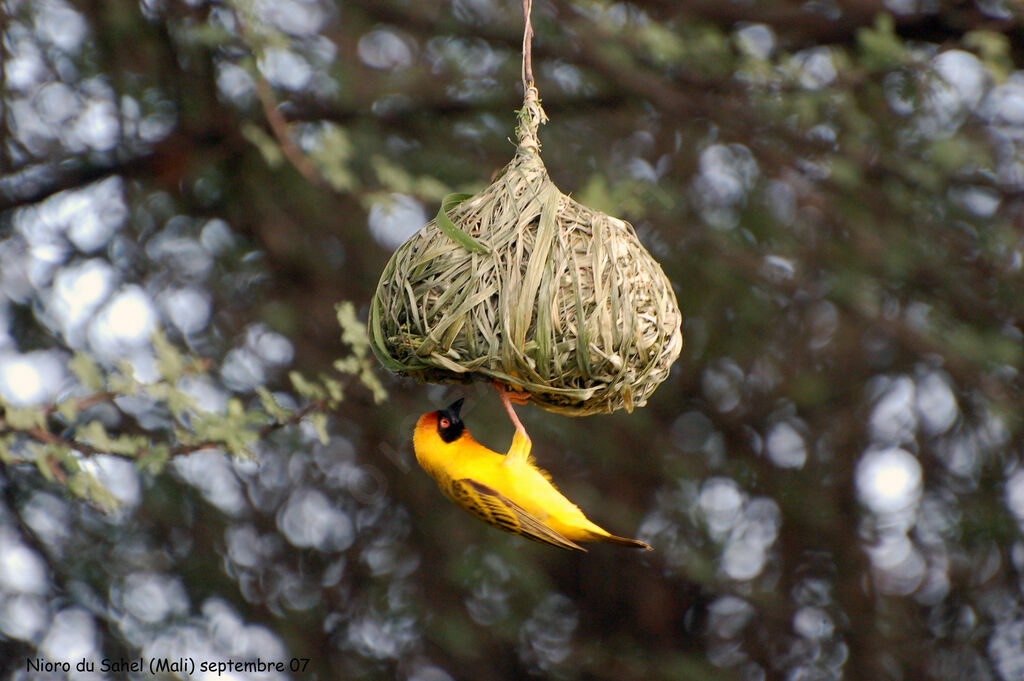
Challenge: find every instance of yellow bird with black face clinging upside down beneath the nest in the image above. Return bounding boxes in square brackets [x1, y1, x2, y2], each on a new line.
[413, 387, 650, 551]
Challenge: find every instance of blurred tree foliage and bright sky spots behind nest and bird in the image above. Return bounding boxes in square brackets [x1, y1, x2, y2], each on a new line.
[0, 0, 1024, 681]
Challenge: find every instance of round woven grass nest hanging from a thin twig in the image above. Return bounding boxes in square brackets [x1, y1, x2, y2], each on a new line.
[370, 87, 683, 416]
